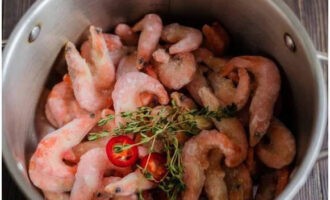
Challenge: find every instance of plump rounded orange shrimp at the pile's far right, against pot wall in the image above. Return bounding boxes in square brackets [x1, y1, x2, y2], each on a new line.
[256, 119, 296, 169]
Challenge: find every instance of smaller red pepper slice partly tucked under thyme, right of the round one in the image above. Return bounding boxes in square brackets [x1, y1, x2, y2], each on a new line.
[140, 153, 167, 181]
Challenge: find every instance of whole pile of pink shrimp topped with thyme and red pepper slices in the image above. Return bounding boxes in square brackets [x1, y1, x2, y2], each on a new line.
[28, 13, 296, 200]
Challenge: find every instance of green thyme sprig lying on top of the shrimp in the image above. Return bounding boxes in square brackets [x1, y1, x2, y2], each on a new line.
[88, 103, 236, 200]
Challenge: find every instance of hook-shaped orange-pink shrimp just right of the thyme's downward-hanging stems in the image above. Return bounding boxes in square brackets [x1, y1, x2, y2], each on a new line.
[182, 130, 240, 200]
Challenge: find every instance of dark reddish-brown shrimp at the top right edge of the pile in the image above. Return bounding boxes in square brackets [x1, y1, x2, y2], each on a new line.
[202, 22, 229, 56]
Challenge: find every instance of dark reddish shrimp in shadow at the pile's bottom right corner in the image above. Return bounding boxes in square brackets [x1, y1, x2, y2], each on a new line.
[255, 168, 290, 200]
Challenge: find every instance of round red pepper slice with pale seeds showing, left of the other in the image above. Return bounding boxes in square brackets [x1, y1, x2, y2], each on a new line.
[106, 135, 138, 167]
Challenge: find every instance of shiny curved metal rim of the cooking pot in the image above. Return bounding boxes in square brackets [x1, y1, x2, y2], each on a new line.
[2, 0, 327, 199]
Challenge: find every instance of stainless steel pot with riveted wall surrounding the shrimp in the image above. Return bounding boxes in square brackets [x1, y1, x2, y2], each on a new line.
[2, 0, 327, 199]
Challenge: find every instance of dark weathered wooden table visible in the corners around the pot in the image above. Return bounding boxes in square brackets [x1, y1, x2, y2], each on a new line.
[2, 0, 328, 200]
